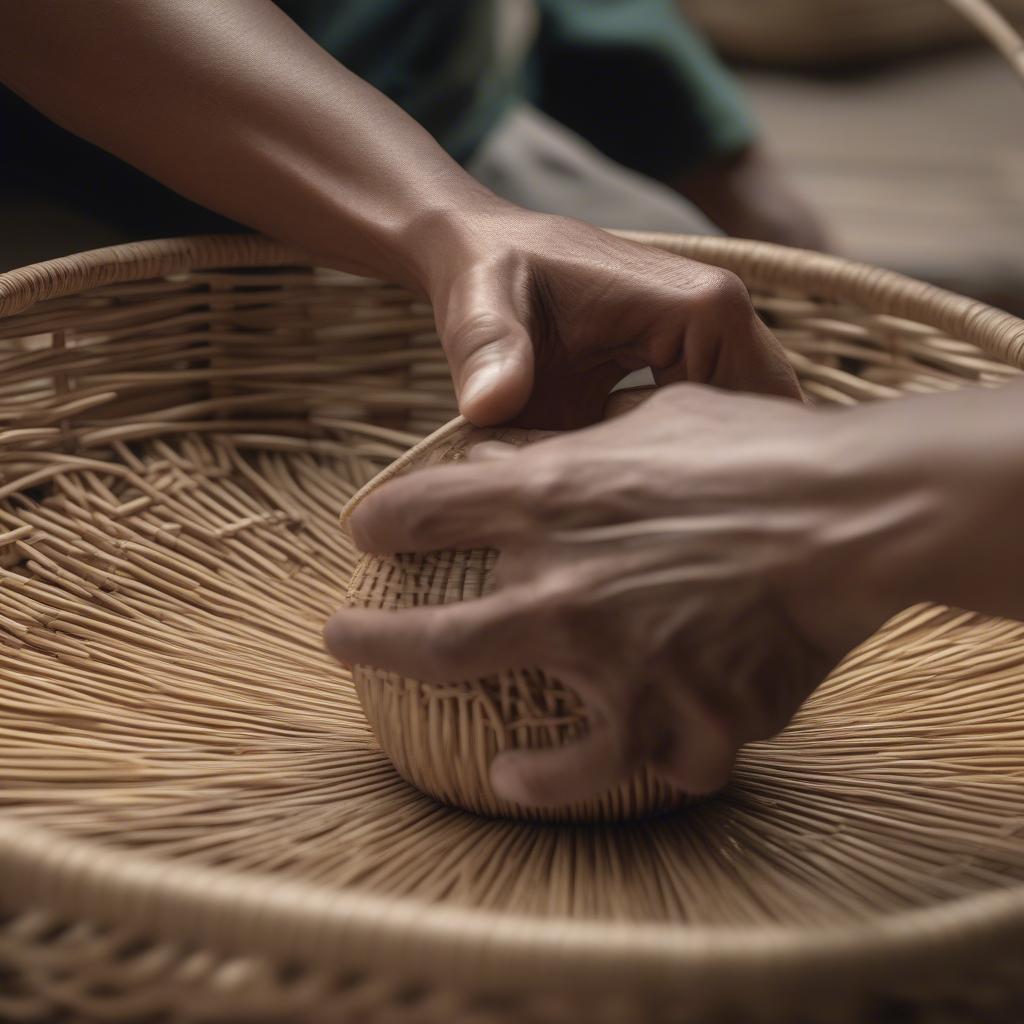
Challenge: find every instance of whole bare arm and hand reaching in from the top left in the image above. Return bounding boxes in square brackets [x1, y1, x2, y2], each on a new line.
[0, 0, 799, 427]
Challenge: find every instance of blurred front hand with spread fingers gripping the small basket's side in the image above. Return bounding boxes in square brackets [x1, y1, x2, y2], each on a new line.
[326, 385, 901, 804]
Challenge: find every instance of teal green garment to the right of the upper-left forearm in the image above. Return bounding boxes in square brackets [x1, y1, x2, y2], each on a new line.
[279, 0, 755, 180]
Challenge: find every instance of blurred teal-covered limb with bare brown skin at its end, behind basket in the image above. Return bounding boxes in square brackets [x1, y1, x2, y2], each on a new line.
[536, 0, 828, 249]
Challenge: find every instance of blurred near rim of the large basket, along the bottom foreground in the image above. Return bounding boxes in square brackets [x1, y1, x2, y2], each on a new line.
[0, 816, 1024, 996]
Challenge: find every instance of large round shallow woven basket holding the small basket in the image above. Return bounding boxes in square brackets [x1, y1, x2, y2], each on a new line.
[0, 237, 1024, 1024]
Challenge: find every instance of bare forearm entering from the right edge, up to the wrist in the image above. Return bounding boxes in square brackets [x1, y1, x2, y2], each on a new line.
[836, 383, 1024, 620]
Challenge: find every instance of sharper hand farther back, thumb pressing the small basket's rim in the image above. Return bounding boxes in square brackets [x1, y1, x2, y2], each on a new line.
[419, 209, 800, 429]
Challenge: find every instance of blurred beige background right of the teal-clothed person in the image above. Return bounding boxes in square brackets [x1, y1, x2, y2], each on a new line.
[683, 0, 1024, 312]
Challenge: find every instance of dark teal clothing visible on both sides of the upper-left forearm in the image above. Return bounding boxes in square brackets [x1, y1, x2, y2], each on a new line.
[0, 0, 754, 238]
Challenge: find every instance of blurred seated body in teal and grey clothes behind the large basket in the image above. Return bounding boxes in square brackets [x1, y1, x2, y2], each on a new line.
[0, 0, 825, 249]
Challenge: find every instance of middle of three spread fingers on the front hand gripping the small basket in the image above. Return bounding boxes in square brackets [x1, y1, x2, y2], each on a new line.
[324, 590, 544, 683]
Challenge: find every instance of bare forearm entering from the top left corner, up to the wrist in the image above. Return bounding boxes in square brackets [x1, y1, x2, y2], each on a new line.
[0, 0, 495, 287]
